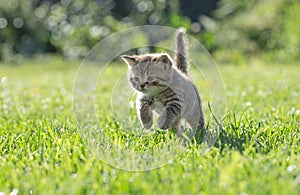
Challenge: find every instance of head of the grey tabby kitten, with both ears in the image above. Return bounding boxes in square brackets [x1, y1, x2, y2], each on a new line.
[122, 54, 173, 94]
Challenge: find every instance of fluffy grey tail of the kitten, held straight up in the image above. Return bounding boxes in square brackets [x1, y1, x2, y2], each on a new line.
[174, 27, 188, 75]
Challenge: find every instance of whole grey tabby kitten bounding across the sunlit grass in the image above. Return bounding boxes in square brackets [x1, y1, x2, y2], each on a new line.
[122, 28, 204, 135]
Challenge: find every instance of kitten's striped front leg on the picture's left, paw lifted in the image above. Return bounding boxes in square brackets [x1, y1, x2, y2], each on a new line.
[137, 99, 153, 129]
